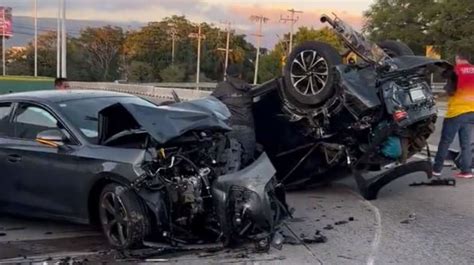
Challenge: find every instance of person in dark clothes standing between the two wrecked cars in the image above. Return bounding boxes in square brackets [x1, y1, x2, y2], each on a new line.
[211, 64, 256, 165]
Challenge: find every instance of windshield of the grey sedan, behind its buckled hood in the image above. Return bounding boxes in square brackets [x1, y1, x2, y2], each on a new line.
[59, 97, 156, 143]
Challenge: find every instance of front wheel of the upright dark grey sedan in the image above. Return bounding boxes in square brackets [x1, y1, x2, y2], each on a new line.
[99, 183, 150, 249]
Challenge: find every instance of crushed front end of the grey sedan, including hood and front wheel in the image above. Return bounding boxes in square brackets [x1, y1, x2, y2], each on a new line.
[99, 98, 288, 250]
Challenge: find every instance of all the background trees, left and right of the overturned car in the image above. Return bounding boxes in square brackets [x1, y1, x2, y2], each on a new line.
[3, 0, 474, 82]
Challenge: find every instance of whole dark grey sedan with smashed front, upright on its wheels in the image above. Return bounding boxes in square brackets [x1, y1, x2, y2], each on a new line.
[0, 90, 287, 249]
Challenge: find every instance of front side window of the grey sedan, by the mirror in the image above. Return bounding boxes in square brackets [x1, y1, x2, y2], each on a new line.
[14, 104, 60, 140]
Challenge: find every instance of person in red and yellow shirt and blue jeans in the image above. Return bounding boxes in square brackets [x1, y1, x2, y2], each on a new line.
[433, 51, 474, 179]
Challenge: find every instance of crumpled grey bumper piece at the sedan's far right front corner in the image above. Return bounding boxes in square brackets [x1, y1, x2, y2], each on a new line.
[212, 153, 287, 244]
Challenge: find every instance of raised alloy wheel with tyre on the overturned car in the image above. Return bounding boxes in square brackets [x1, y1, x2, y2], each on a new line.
[284, 41, 342, 108]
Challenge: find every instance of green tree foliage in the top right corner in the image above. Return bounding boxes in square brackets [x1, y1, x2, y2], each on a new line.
[364, 0, 474, 60]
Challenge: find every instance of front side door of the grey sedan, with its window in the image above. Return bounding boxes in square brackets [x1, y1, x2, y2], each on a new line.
[7, 103, 87, 218]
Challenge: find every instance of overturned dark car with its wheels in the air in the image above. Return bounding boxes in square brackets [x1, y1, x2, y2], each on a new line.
[253, 15, 452, 199]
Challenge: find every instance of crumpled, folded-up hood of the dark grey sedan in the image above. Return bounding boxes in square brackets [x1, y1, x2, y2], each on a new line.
[99, 97, 231, 144]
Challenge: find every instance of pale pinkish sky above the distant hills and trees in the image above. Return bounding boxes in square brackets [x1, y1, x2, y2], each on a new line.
[0, 0, 374, 47]
